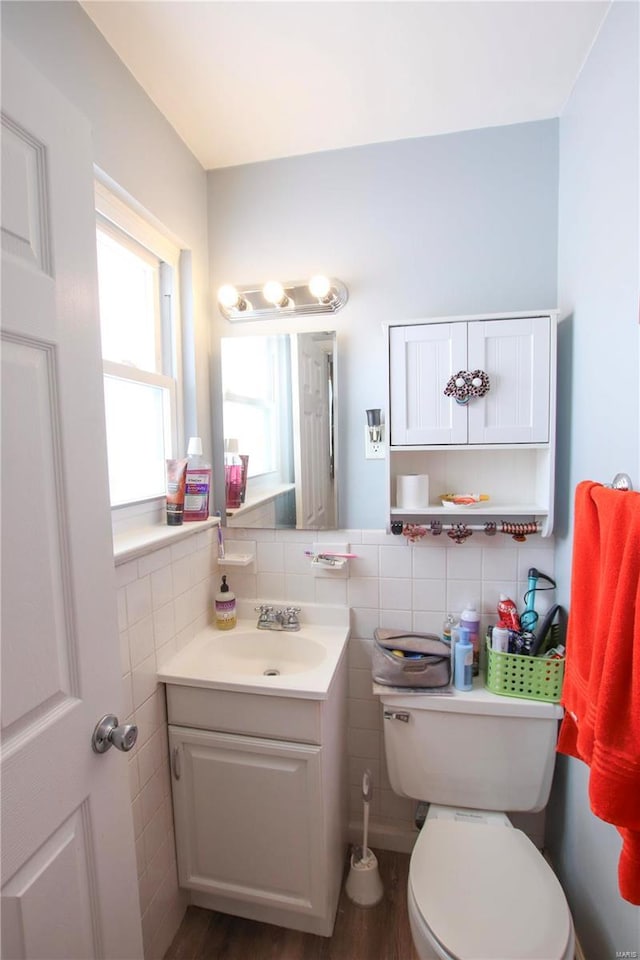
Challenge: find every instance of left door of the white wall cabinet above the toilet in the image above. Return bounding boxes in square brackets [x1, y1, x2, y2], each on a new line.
[389, 323, 467, 446]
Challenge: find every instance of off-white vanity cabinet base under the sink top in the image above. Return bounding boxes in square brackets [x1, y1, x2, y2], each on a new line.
[162, 657, 347, 936]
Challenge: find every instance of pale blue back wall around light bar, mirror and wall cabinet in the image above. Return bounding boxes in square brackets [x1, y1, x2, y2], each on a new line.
[208, 120, 558, 529]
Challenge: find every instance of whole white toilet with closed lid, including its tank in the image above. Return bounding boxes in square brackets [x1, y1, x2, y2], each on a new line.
[376, 687, 574, 960]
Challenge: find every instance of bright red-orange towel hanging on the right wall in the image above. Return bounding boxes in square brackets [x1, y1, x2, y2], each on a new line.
[558, 481, 640, 905]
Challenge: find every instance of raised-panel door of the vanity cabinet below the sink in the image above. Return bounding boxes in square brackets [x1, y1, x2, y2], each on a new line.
[169, 726, 326, 915]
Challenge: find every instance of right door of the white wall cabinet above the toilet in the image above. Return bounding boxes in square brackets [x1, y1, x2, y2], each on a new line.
[468, 317, 550, 443]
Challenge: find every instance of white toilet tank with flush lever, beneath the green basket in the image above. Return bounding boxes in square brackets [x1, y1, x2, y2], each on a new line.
[375, 685, 563, 812]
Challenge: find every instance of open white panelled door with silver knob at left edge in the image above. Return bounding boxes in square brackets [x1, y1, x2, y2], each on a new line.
[1, 44, 142, 960]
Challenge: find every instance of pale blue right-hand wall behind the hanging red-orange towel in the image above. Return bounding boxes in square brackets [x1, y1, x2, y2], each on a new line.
[548, 0, 640, 960]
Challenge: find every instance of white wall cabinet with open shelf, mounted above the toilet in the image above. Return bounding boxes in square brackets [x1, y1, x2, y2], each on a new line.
[389, 311, 557, 535]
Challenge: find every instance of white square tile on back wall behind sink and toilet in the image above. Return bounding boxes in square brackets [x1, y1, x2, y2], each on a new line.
[227, 529, 554, 849]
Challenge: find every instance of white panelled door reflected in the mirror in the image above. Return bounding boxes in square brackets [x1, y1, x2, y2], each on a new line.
[292, 333, 336, 530]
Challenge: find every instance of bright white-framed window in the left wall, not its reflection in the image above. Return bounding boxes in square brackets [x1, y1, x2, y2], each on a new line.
[96, 184, 180, 507]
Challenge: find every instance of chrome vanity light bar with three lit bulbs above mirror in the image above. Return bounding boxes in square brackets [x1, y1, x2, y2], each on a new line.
[218, 274, 349, 323]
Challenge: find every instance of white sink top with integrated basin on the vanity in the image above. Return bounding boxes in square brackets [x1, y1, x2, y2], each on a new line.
[158, 620, 349, 699]
